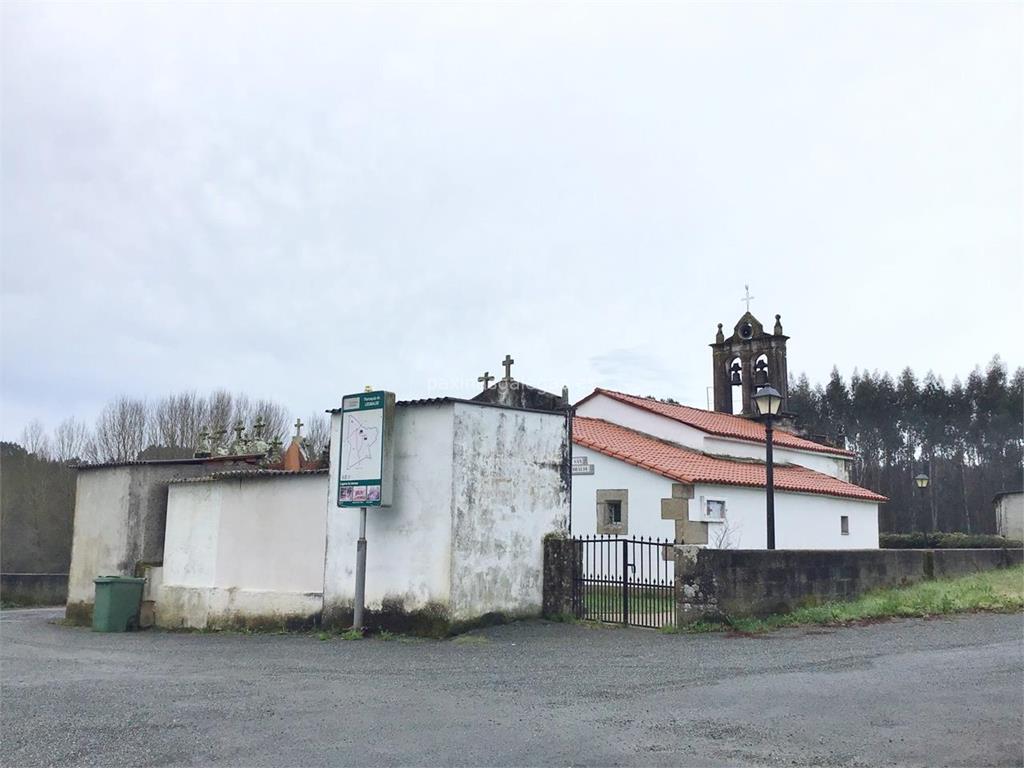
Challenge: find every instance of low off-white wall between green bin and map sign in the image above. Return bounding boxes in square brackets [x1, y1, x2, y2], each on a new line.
[156, 473, 328, 628]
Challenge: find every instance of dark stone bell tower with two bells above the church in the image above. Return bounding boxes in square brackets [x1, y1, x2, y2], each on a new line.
[711, 304, 790, 417]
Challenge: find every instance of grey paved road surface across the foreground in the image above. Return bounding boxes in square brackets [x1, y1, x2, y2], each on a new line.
[0, 610, 1024, 766]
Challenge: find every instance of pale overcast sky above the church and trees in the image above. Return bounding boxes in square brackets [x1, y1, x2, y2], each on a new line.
[0, 2, 1024, 438]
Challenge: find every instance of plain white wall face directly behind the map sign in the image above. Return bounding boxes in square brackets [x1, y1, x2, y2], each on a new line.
[324, 402, 455, 625]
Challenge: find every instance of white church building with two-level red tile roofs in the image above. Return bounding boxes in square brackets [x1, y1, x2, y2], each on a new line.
[571, 389, 886, 549]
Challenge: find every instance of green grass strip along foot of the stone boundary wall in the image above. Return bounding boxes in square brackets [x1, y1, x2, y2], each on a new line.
[687, 565, 1024, 634]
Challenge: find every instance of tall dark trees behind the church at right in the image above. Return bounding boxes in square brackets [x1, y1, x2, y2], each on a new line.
[790, 355, 1024, 534]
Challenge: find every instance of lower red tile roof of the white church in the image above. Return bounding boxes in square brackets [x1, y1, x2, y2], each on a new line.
[572, 416, 888, 502]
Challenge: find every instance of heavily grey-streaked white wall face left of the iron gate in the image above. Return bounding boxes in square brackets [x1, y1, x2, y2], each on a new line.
[450, 403, 570, 621]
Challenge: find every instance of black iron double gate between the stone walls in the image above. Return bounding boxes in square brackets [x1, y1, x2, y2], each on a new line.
[572, 536, 676, 629]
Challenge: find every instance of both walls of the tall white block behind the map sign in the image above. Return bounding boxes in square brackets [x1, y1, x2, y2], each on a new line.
[324, 400, 569, 633]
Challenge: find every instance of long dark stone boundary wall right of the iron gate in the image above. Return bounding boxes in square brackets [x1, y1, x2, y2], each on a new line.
[676, 545, 1024, 625]
